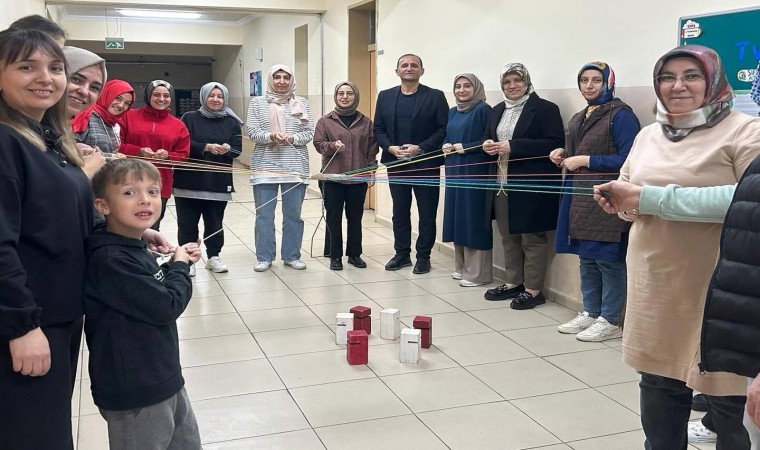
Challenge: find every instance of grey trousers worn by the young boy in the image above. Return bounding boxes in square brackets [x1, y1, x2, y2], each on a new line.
[100, 388, 201, 450]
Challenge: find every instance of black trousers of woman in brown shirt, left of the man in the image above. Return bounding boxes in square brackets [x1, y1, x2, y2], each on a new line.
[324, 181, 367, 259]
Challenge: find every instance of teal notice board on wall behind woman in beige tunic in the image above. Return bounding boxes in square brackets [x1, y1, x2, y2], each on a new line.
[678, 8, 760, 114]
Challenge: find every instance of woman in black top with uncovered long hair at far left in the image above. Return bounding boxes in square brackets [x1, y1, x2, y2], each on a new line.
[0, 30, 95, 450]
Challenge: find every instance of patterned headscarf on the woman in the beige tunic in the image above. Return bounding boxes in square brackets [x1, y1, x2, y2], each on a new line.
[654, 45, 734, 142]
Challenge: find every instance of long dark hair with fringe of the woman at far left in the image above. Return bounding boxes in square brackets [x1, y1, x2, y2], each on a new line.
[0, 28, 84, 167]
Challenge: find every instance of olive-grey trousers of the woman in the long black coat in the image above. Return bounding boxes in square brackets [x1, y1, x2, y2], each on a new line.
[493, 195, 549, 291]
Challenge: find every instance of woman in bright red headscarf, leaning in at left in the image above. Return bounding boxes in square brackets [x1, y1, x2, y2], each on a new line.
[71, 80, 134, 156]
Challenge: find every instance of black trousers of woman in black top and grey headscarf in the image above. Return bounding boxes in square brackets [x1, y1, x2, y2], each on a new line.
[174, 197, 227, 258]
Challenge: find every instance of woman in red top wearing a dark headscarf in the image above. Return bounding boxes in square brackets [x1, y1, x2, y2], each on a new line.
[121, 80, 190, 230]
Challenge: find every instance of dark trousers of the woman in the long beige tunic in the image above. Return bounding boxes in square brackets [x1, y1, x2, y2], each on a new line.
[639, 372, 750, 450]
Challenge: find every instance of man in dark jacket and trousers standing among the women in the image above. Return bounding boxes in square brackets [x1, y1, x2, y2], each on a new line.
[374, 54, 449, 274]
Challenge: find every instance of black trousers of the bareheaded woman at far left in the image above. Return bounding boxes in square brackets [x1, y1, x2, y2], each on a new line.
[0, 318, 82, 450]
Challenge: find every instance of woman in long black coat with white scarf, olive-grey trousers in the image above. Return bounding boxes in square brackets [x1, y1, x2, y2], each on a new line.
[483, 63, 565, 309]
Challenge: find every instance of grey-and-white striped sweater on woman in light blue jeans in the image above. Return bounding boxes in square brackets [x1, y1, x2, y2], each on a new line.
[245, 96, 314, 185]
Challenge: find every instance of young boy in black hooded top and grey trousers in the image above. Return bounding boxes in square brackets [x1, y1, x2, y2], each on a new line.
[84, 159, 201, 450]
